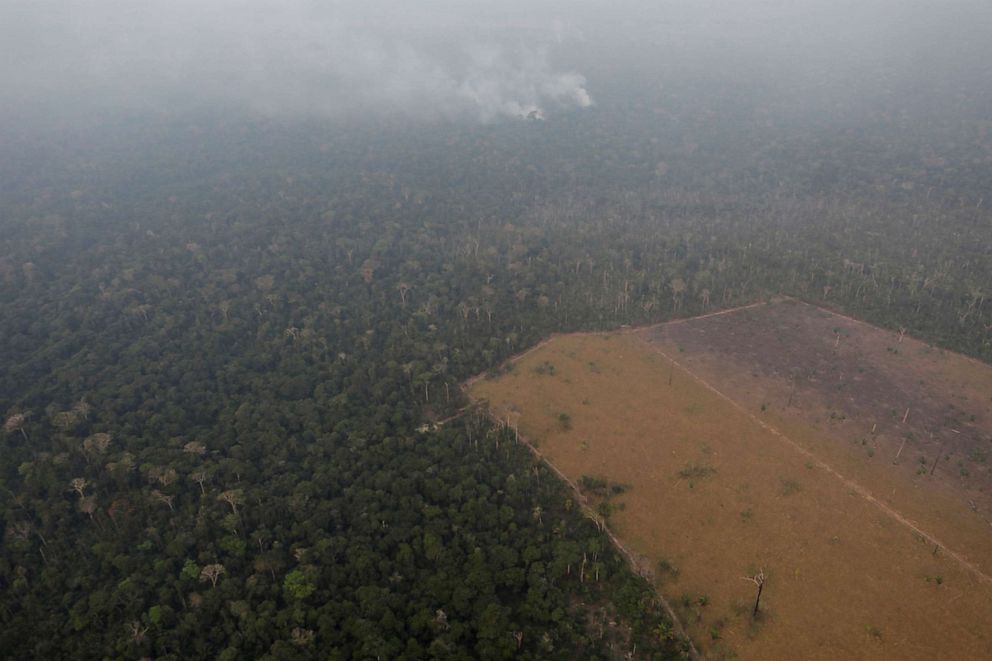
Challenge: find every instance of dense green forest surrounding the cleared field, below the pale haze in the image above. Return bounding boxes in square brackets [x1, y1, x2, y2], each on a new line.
[0, 65, 992, 659]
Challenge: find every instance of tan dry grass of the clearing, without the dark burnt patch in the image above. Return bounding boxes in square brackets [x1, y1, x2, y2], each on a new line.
[470, 306, 992, 659]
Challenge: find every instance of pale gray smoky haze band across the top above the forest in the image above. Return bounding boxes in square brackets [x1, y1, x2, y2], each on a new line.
[0, 0, 992, 121]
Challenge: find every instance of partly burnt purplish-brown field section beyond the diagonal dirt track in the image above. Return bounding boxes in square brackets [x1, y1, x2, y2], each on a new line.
[640, 300, 992, 571]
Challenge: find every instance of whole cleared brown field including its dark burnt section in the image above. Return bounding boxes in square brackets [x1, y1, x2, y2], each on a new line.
[468, 301, 992, 659]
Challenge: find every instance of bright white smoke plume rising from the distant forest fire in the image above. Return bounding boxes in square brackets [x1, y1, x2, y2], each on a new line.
[243, 35, 592, 122]
